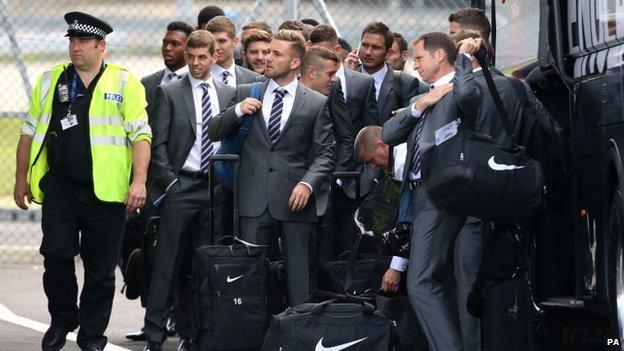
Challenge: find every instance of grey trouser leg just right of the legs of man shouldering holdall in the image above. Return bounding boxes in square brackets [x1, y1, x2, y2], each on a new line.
[453, 217, 483, 351]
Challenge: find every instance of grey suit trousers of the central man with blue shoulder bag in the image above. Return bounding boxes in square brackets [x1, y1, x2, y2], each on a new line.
[241, 208, 316, 306]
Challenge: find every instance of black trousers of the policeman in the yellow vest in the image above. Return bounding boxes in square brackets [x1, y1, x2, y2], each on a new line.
[40, 174, 125, 347]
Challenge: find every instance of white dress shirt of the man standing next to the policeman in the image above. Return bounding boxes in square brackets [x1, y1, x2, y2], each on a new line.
[182, 75, 221, 172]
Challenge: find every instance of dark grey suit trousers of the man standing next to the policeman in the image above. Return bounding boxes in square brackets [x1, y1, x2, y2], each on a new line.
[145, 176, 216, 343]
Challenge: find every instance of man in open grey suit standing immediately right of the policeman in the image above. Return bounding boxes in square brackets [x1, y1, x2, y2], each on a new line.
[145, 30, 235, 350]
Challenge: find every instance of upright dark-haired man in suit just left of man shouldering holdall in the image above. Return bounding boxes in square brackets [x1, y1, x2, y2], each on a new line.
[345, 22, 426, 125]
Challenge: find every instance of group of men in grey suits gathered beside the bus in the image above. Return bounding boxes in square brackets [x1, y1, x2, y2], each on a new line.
[133, 6, 552, 351]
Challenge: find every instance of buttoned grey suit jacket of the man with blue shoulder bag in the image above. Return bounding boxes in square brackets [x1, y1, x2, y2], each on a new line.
[208, 82, 335, 222]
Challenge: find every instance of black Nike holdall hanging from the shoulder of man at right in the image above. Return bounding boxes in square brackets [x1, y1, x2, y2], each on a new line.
[421, 46, 546, 223]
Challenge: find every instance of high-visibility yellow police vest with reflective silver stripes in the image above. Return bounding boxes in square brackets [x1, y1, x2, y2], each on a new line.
[21, 63, 152, 203]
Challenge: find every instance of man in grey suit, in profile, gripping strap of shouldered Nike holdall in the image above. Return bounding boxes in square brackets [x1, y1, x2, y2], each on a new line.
[382, 33, 481, 351]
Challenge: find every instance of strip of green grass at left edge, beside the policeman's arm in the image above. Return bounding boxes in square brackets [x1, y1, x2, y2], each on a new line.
[0, 118, 22, 207]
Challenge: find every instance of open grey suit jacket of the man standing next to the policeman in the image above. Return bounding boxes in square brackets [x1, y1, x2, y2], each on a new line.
[149, 76, 236, 201]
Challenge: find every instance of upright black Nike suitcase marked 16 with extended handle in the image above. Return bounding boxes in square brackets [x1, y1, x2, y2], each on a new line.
[191, 155, 269, 351]
